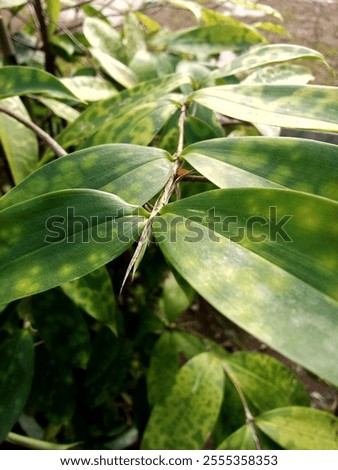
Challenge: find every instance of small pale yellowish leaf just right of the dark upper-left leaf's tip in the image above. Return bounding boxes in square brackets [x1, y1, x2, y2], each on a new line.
[60, 76, 117, 101]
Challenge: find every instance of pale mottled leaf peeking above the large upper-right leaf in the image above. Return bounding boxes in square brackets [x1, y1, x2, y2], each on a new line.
[241, 64, 314, 85]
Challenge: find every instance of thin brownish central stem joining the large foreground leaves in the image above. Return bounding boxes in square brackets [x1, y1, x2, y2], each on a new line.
[120, 103, 187, 294]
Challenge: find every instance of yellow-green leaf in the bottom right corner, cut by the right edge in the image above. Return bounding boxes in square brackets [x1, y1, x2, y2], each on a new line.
[256, 406, 338, 450]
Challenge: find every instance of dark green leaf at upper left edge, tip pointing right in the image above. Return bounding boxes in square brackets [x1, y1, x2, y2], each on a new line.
[0, 65, 78, 101]
